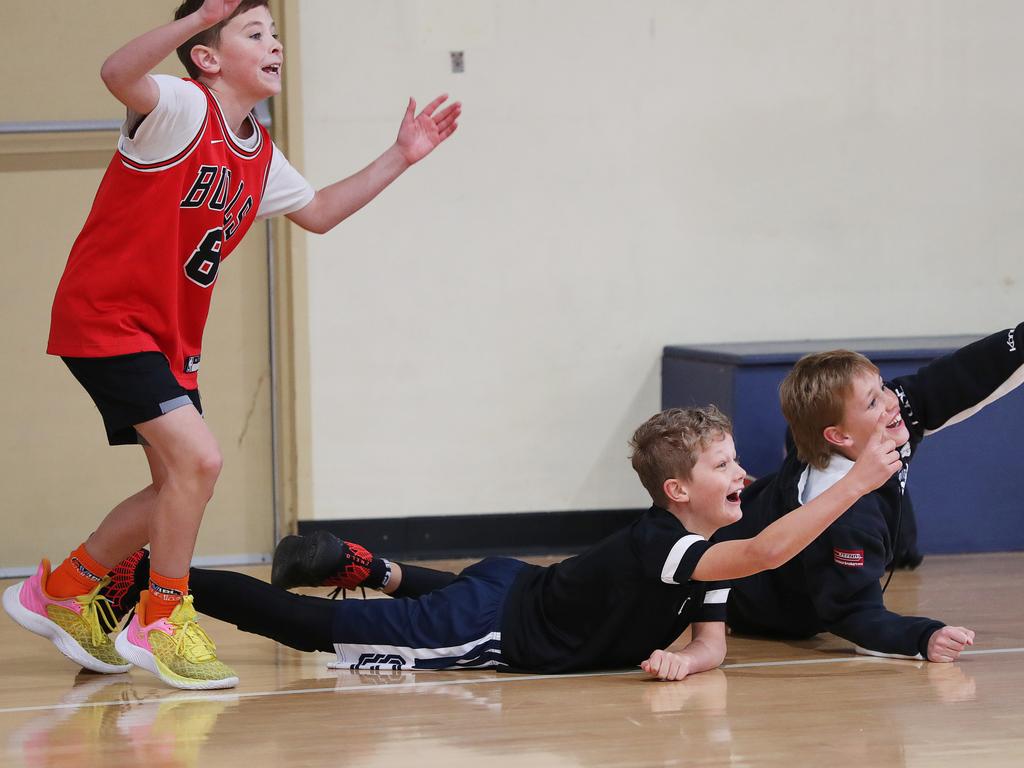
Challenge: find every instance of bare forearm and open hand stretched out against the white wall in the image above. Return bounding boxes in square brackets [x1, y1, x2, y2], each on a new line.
[288, 94, 462, 234]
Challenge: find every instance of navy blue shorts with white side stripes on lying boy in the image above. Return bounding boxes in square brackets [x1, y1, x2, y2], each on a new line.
[330, 557, 525, 670]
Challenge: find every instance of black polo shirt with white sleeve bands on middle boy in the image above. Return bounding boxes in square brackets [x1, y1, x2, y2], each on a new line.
[501, 507, 729, 673]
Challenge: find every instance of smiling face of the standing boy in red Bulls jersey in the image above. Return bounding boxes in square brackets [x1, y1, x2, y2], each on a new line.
[204, 6, 284, 103]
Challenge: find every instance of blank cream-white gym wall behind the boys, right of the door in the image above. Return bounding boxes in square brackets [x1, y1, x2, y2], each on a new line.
[288, 0, 1024, 519]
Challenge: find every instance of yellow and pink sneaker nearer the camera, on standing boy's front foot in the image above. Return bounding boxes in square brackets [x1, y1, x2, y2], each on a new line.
[114, 592, 239, 690]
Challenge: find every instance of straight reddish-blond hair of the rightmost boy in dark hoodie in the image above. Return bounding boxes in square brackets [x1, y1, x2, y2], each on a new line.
[778, 349, 879, 469]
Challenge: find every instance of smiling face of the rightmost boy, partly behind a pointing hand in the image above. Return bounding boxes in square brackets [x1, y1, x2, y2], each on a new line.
[824, 372, 910, 461]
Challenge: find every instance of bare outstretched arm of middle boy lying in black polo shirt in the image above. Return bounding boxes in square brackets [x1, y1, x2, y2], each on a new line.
[692, 413, 902, 582]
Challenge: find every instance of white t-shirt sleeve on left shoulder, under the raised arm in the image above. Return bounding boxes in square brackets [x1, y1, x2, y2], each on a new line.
[118, 75, 207, 163]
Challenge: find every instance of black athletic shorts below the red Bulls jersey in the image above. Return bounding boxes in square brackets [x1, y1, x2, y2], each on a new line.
[60, 352, 203, 445]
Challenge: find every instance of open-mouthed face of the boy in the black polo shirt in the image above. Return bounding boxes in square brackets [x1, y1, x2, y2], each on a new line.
[666, 434, 746, 538]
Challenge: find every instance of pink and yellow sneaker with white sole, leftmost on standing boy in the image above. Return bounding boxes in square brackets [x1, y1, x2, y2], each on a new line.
[3, 559, 131, 675]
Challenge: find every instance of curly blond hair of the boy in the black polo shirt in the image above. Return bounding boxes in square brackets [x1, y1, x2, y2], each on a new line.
[630, 406, 732, 507]
